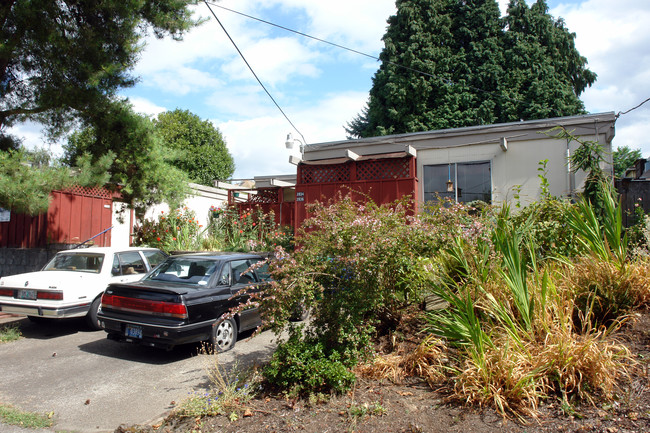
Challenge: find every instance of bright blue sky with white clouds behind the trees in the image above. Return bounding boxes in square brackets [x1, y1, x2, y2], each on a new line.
[11, 0, 650, 179]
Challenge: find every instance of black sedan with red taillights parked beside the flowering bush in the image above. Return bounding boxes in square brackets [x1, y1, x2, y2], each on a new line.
[98, 253, 269, 352]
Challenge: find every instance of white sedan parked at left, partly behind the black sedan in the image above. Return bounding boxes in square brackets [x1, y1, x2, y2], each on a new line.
[0, 247, 167, 329]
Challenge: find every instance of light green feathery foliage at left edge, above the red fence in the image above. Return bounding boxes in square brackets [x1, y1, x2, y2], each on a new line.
[0, 148, 114, 215]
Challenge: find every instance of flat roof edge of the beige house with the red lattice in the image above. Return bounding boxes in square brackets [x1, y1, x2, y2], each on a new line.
[303, 112, 616, 163]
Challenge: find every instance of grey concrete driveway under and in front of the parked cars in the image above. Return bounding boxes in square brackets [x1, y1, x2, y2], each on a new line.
[0, 318, 275, 433]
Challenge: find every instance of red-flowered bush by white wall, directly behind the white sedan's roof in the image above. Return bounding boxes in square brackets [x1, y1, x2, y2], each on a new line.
[132, 207, 204, 252]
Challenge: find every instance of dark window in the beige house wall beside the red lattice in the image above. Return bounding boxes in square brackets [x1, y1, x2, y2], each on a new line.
[423, 162, 492, 203]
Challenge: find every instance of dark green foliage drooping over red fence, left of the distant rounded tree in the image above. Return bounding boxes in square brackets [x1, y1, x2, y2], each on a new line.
[64, 101, 189, 218]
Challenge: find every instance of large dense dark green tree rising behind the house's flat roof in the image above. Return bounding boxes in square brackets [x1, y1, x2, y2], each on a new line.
[346, 0, 596, 137]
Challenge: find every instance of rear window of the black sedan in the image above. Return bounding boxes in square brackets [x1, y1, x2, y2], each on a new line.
[145, 257, 219, 286]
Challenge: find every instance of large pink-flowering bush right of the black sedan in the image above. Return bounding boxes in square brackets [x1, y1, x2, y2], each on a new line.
[247, 196, 488, 393]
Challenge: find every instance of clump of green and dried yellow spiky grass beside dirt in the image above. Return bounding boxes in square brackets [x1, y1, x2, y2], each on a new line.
[428, 202, 638, 417]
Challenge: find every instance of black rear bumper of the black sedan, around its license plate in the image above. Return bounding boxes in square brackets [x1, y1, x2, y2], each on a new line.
[97, 311, 214, 350]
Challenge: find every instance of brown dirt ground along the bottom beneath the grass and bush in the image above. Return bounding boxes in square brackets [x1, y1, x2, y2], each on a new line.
[115, 311, 650, 433]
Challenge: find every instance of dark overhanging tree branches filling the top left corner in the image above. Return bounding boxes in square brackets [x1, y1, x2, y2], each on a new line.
[0, 0, 195, 138]
